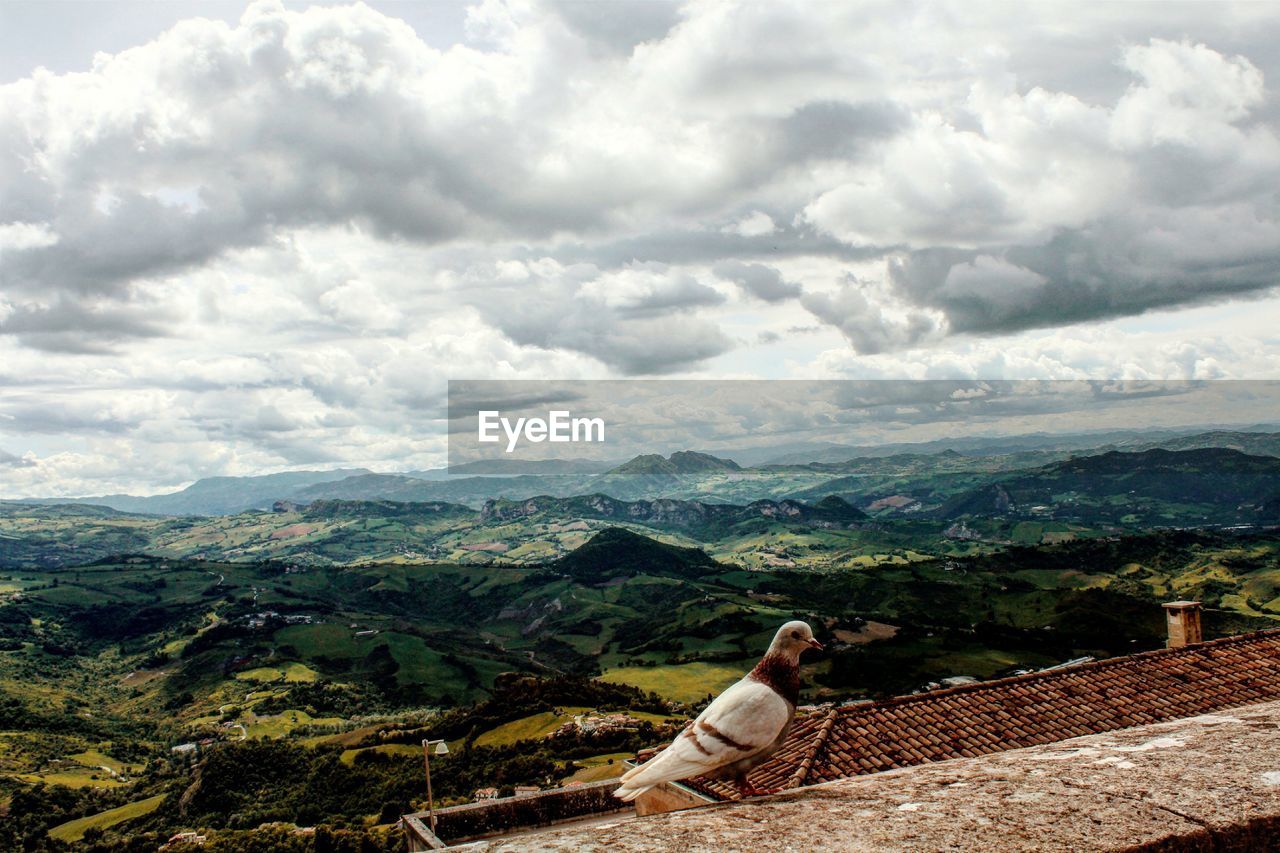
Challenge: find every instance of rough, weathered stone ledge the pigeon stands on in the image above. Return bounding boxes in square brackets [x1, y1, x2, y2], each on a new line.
[479, 702, 1280, 850]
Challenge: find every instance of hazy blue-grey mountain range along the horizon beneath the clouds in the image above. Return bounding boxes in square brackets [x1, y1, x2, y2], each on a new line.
[22, 429, 1280, 516]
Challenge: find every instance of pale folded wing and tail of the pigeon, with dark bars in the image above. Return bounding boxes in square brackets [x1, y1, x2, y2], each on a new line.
[614, 679, 792, 800]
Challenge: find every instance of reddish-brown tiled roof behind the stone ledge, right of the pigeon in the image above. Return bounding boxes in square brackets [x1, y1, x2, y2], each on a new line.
[685, 630, 1280, 799]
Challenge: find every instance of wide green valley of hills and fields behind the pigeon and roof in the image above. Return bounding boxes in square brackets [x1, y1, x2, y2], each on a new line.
[0, 439, 1280, 849]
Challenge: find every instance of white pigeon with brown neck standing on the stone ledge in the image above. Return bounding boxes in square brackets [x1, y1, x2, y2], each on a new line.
[613, 621, 822, 802]
